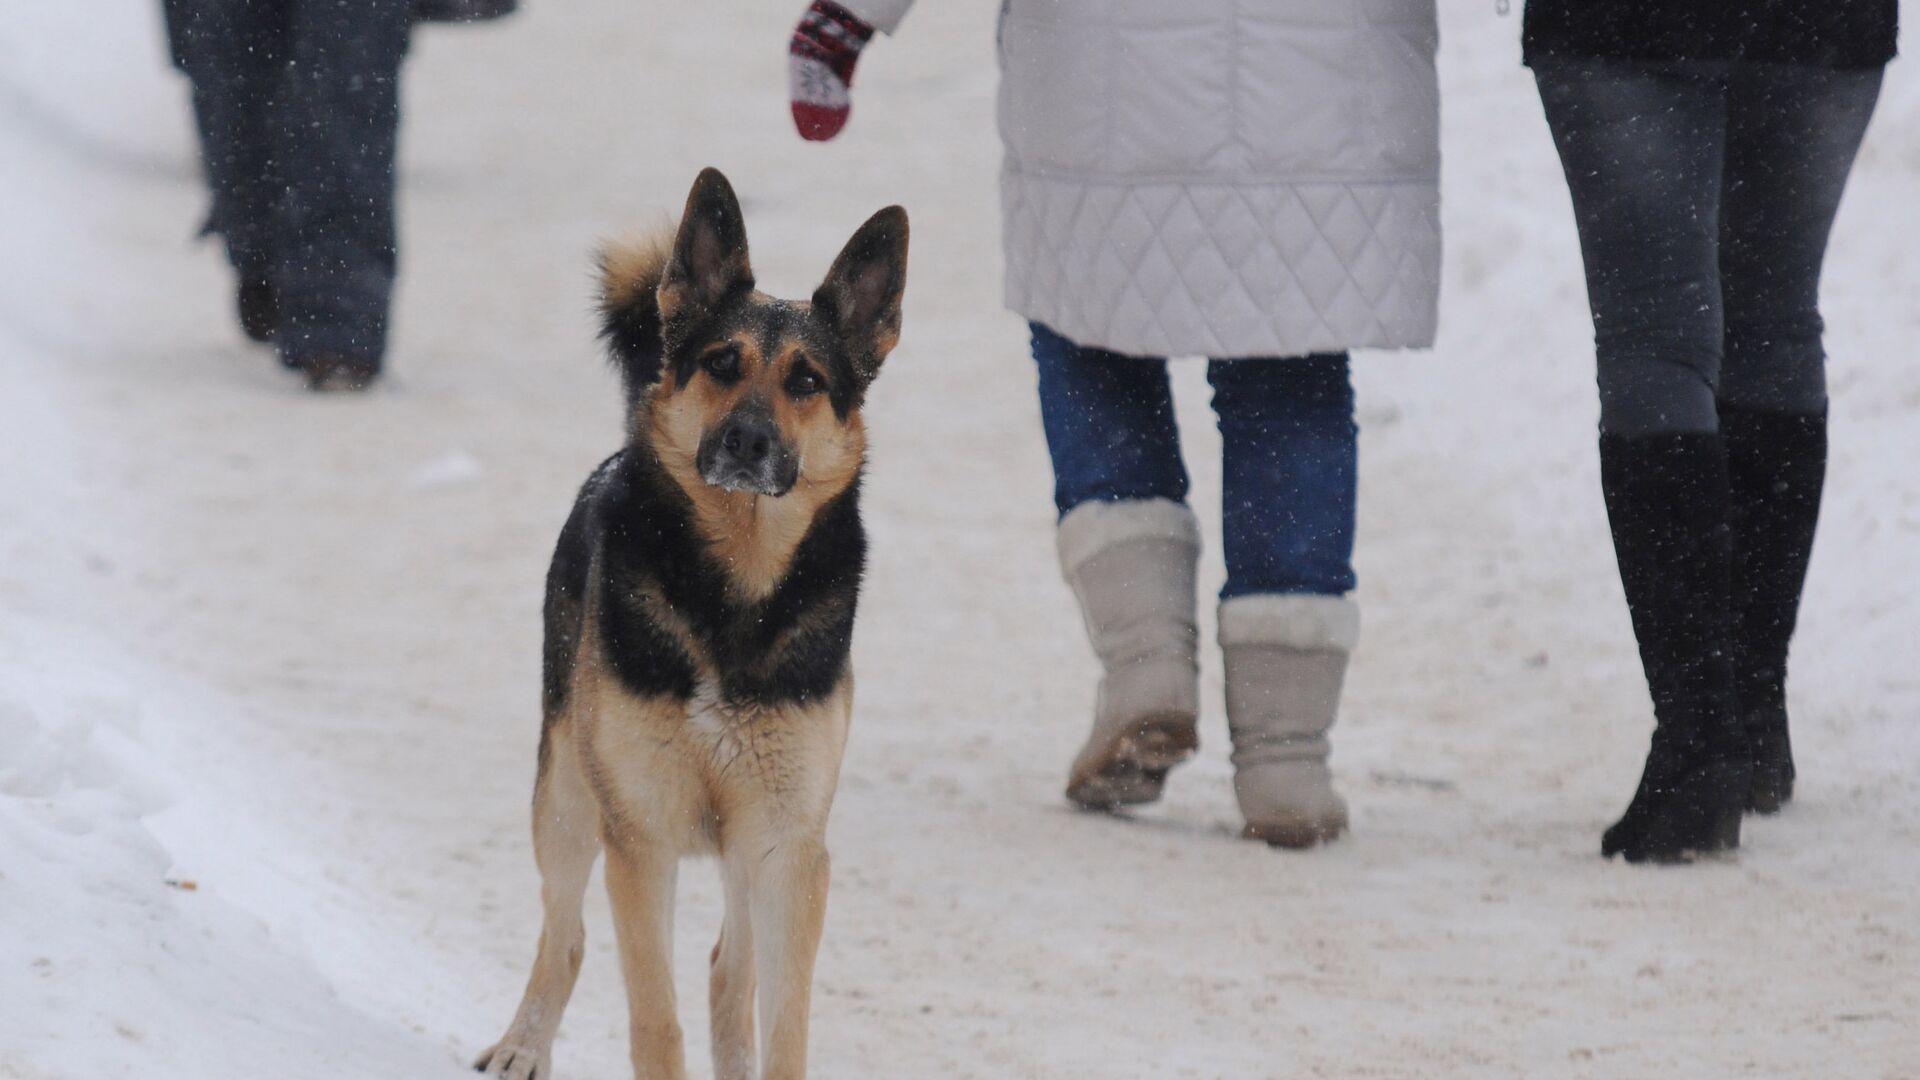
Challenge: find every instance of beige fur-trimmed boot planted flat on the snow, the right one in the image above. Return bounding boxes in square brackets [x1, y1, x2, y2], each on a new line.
[1219, 594, 1359, 847]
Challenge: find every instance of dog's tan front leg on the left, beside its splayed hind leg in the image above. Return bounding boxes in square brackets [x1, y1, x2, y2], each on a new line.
[607, 830, 687, 1080]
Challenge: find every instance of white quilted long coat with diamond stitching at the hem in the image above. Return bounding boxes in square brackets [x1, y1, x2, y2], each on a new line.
[841, 0, 1440, 357]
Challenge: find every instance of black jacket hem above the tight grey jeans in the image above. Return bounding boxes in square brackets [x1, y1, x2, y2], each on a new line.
[1521, 0, 1899, 67]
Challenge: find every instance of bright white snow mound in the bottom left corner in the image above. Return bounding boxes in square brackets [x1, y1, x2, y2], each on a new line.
[0, 619, 468, 1080]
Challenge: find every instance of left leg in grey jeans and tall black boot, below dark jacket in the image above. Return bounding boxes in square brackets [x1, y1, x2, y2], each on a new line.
[1536, 61, 1749, 861]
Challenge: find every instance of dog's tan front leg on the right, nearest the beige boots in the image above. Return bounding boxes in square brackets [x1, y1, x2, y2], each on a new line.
[749, 834, 829, 1080]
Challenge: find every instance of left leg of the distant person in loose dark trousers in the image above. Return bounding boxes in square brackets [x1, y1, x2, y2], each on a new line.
[167, 0, 286, 342]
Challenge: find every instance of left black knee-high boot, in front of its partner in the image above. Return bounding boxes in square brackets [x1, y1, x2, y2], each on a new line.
[1599, 432, 1753, 863]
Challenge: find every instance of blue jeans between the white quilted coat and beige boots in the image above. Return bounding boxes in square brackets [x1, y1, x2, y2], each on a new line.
[1033, 323, 1359, 600]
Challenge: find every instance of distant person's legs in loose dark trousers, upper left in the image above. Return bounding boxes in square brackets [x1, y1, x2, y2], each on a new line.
[167, 0, 413, 390]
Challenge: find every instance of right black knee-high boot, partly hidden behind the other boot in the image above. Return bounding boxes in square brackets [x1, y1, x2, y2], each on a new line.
[1720, 405, 1826, 813]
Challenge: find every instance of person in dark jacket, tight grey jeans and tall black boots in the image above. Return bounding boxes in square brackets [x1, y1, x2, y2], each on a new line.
[1524, 0, 1897, 861]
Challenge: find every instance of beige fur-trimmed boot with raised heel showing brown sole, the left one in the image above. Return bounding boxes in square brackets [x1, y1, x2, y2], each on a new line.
[1060, 500, 1200, 809]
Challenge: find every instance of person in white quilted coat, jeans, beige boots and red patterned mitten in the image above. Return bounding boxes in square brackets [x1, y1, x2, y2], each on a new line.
[791, 0, 1440, 847]
